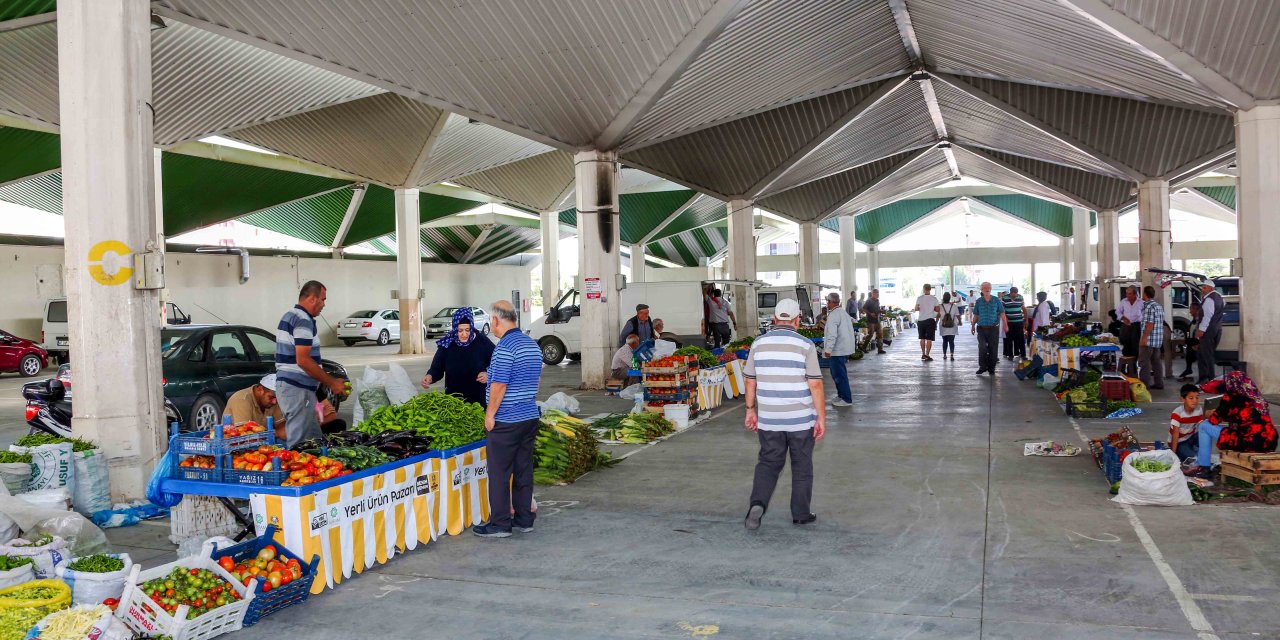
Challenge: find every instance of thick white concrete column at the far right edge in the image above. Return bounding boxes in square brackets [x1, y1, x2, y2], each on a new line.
[1235, 105, 1280, 394]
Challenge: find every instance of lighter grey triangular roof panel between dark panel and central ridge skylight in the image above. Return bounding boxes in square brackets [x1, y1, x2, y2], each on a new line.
[771, 82, 937, 192]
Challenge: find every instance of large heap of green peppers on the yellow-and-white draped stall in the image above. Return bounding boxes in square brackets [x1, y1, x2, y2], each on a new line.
[356, 392, 485, 449]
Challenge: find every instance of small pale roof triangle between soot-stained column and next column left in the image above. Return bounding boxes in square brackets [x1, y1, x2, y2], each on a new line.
[410, 114, 552, 187]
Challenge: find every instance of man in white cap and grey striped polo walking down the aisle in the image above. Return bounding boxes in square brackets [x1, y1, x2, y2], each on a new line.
[744, 298, 827, 531]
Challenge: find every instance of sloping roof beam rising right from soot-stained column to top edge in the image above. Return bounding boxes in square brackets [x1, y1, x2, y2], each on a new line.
[594, 0, 746, 151]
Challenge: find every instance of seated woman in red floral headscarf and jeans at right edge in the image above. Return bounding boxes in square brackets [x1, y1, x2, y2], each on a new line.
[1184, 371, 1276, 477]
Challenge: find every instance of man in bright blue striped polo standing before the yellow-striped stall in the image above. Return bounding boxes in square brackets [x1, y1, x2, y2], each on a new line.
[471, 300, 543, 538]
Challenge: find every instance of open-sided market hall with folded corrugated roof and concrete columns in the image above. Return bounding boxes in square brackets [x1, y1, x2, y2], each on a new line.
[0, 0, 1280, 639]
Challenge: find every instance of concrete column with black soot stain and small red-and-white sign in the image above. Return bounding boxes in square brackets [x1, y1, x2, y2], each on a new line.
[573, 151, 622, 389]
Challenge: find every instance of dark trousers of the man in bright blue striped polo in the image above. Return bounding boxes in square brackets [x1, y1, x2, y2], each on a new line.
[488, 420, 539, 529]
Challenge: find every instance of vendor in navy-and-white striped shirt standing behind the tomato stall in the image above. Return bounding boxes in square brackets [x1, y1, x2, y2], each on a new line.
[275, 280, 347, 448]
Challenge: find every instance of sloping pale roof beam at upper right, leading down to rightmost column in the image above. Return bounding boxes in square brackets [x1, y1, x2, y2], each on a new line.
[1059, 0, 1256, 109]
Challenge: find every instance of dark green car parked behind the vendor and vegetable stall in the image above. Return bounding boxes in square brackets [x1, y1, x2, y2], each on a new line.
[160, 325, 349, 430]
